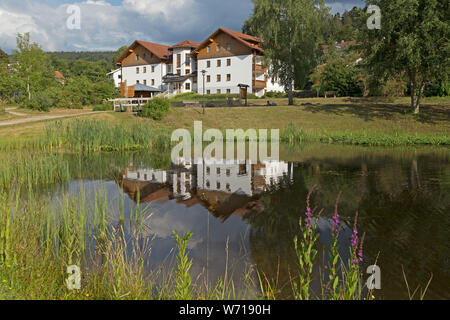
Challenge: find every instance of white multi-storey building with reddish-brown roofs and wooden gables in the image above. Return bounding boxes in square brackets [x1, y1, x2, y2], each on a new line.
[117, 28, 284, 97]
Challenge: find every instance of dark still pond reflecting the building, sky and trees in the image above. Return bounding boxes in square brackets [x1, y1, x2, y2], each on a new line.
[36, 144, 450, 299]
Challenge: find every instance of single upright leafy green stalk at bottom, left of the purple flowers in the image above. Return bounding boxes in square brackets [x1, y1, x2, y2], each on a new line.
[173, 231, 193, 300]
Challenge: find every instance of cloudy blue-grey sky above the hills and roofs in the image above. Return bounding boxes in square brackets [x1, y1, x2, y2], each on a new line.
[0, 0, 364, 53]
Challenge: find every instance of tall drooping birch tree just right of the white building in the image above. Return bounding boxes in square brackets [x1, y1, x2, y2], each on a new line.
[245, 0, 327, 105]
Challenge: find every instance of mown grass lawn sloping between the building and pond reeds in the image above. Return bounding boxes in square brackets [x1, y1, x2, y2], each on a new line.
[0, 97, 450, 144]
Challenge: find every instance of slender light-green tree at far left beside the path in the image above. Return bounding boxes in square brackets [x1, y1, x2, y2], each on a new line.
[14, 33, 53, 100]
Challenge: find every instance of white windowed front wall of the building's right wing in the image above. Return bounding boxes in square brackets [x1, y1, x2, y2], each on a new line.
[198, 55, 253, 94]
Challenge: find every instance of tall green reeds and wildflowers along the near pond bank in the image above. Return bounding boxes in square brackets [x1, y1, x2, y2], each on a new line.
[0, 178, 373, 300]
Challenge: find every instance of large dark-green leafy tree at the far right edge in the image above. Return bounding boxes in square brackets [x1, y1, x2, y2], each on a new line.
[361, 0, 450, 114]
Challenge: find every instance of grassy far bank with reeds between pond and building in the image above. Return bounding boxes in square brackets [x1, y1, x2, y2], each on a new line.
[0, 98, 450, 151]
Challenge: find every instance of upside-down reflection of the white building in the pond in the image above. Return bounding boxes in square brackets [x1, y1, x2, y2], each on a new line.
[119, 158, 293, 221]
